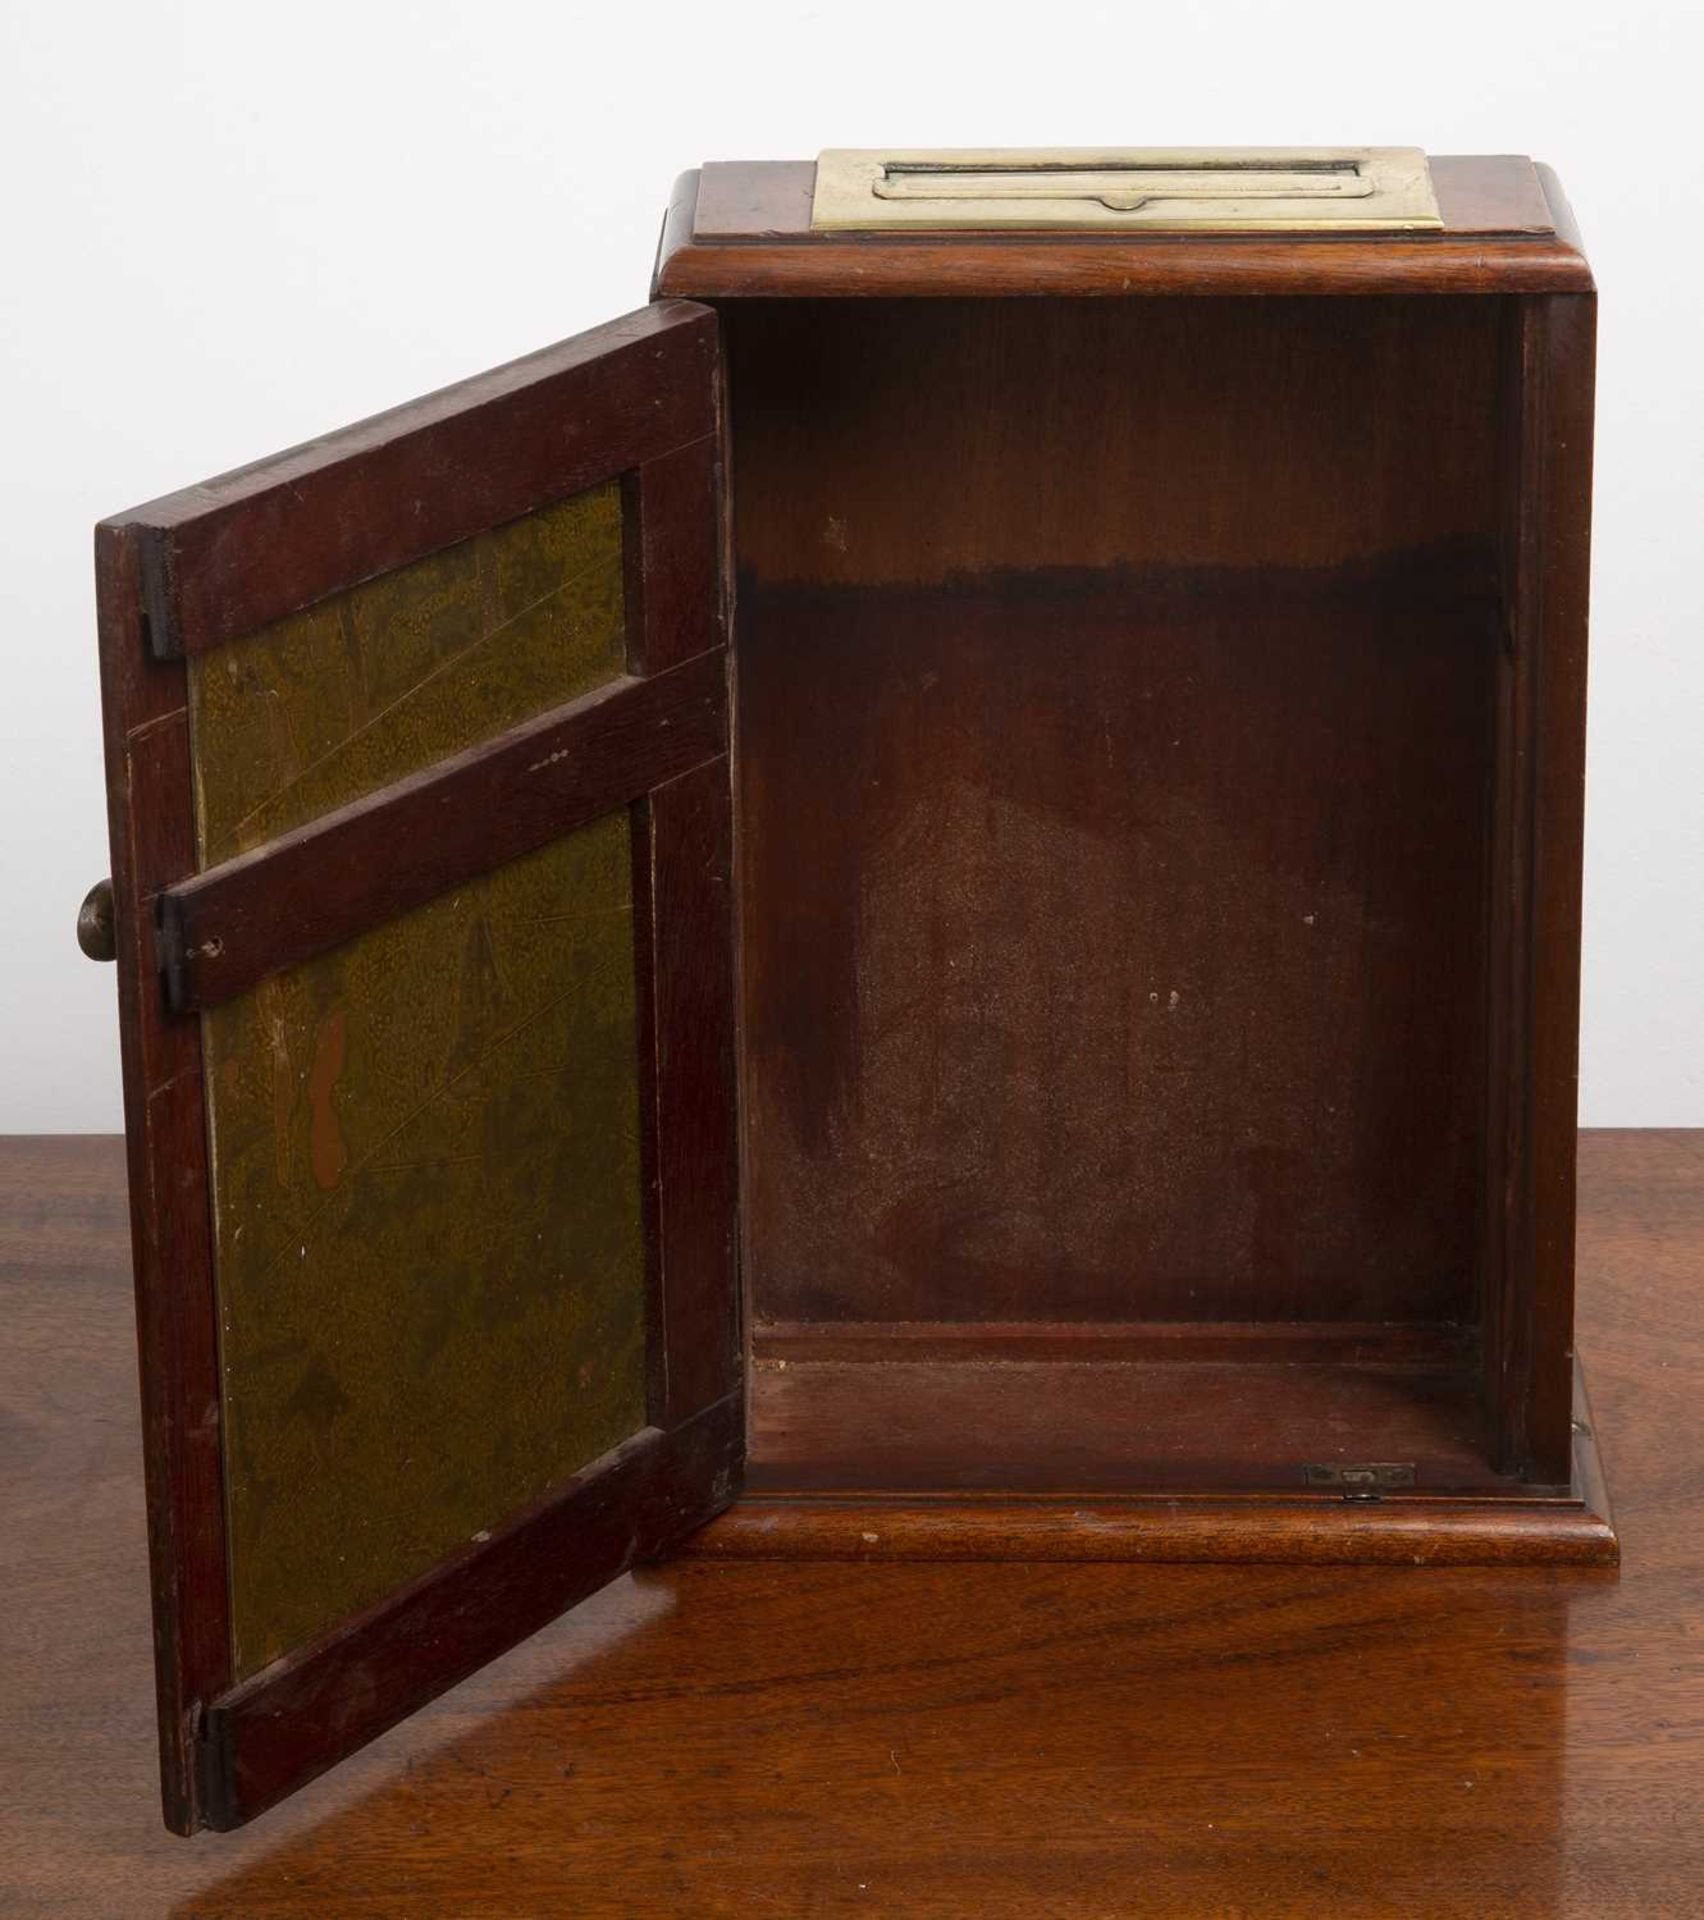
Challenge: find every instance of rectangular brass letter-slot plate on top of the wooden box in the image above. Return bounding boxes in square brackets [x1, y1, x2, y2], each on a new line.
[810, 146, 1443, 232]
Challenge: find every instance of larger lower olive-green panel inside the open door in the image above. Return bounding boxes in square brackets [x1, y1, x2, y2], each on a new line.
[203, 810, 647, 1680]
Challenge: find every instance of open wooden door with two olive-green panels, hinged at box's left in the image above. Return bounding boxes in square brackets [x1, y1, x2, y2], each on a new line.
[86, 301, 743, 1832]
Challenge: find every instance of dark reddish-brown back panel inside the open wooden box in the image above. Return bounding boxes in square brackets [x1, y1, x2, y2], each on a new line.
[725, 298, 1501, 1351]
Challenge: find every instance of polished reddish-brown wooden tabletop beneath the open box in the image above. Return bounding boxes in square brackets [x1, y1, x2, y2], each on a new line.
[0, 1133, 1704, 1920]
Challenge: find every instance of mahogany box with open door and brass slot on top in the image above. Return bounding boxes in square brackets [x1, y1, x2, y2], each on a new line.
[83, 148, 1616, 1832]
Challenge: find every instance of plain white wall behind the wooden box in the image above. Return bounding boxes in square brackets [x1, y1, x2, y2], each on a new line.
[0, 0, 1704, 1131]
